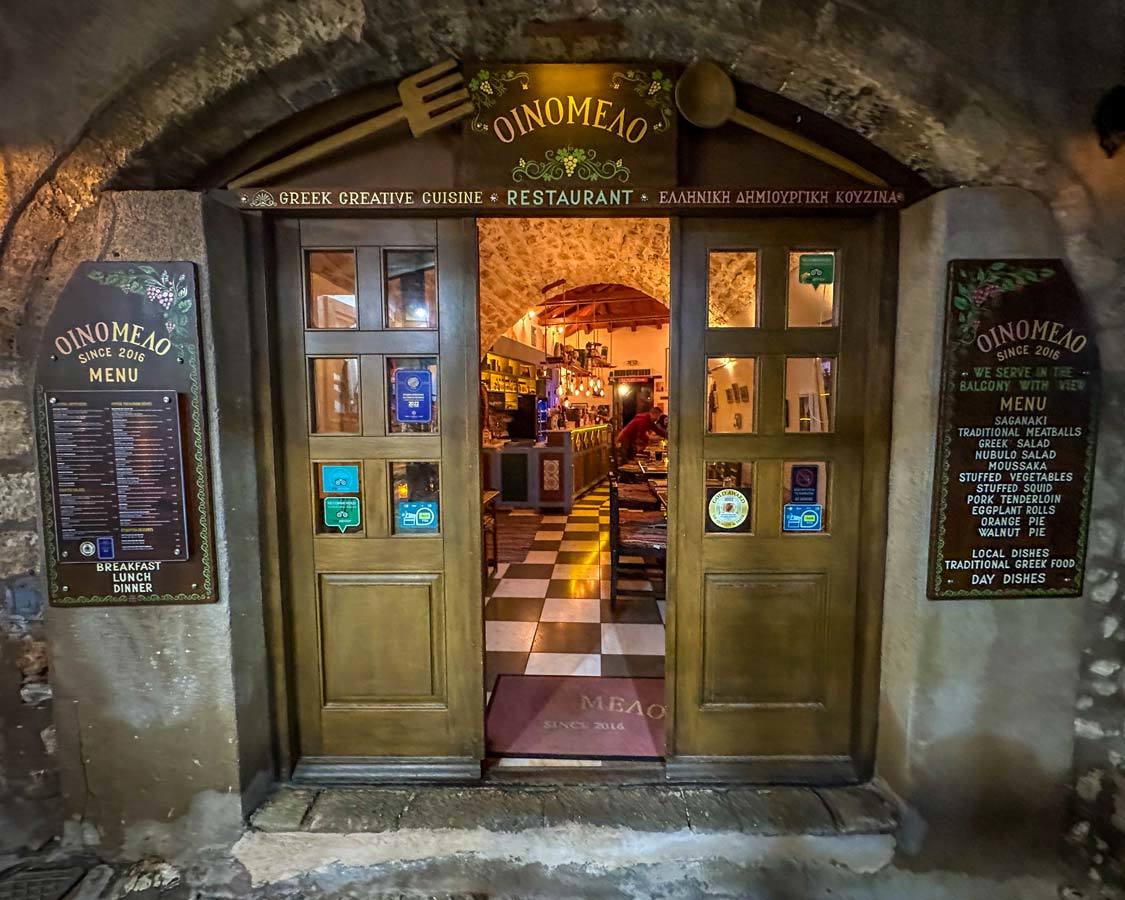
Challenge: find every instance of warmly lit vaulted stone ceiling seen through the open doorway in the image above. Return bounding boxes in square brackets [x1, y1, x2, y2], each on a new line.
[477, 218, 669, 351]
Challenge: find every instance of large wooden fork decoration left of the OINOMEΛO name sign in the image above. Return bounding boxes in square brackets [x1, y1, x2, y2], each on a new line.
[227, 60, 473, 188]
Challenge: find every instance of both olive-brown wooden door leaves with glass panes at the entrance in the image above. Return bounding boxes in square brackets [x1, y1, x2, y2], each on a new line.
[273, 218, 890, 782]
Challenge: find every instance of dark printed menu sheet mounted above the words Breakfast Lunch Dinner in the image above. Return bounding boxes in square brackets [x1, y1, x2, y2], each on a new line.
[47, 390, 188, 563]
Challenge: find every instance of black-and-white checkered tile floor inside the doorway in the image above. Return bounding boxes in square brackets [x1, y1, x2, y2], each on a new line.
[485, 486, 665, 691]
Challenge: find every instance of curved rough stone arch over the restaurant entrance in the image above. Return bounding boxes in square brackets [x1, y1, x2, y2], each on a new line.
[0, 0, 1123, 357]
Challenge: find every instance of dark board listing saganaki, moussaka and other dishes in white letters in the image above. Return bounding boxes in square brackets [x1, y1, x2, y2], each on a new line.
[927, 260, 1098, 600]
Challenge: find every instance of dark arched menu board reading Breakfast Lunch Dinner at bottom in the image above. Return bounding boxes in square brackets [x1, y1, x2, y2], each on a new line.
[36, 262, 216, 606]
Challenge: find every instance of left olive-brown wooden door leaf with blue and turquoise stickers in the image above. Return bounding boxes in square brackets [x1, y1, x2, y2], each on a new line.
[275, 219, 483, 781]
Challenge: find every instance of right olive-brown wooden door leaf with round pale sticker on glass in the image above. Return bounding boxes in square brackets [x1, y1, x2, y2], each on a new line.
[668, 219, 885, 780]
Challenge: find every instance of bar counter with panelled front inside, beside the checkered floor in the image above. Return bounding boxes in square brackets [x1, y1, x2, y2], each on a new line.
[484, 425, 610, 513]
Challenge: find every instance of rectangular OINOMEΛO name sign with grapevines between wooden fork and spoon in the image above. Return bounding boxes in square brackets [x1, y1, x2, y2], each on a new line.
[460, 63, 677, 187]
